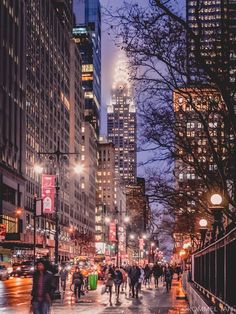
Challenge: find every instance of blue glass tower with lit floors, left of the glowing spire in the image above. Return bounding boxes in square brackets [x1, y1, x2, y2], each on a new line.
[73, 0, 101, 136]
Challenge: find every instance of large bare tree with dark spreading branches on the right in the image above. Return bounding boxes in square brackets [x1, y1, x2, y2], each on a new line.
[106, 0, 236, 221]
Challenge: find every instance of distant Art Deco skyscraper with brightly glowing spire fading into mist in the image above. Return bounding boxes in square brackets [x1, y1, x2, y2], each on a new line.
[107, 60, 137, 183]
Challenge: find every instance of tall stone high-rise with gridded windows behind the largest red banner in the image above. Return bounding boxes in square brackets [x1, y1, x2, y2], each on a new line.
[24, 0, 84, 260]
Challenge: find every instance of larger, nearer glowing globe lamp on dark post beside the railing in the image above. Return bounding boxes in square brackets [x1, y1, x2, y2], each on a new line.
[210, 193, 224, 241]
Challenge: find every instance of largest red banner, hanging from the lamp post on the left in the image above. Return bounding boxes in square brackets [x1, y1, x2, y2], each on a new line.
[42, 174, 55, 214]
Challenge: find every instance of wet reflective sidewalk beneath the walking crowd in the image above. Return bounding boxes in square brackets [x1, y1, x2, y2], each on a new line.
[52, 279, 189, 314]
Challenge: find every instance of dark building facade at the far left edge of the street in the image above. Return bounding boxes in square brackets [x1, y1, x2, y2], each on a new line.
[0, 0, 26, 262]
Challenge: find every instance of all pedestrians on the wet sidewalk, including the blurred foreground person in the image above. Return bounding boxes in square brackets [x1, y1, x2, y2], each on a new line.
[28, 260, 182, 314]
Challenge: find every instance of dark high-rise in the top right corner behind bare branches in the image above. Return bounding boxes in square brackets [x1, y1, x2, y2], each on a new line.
[187, 0, 236, 84]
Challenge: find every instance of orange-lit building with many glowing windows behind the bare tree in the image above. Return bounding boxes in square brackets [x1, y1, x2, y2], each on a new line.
[173, 87, 227, 234]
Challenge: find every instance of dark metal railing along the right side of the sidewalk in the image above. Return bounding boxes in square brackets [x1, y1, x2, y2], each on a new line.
[192, 228, 236, 313]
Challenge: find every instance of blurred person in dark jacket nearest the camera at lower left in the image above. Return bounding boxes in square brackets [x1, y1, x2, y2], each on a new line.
[31, 260, 55, 314]
